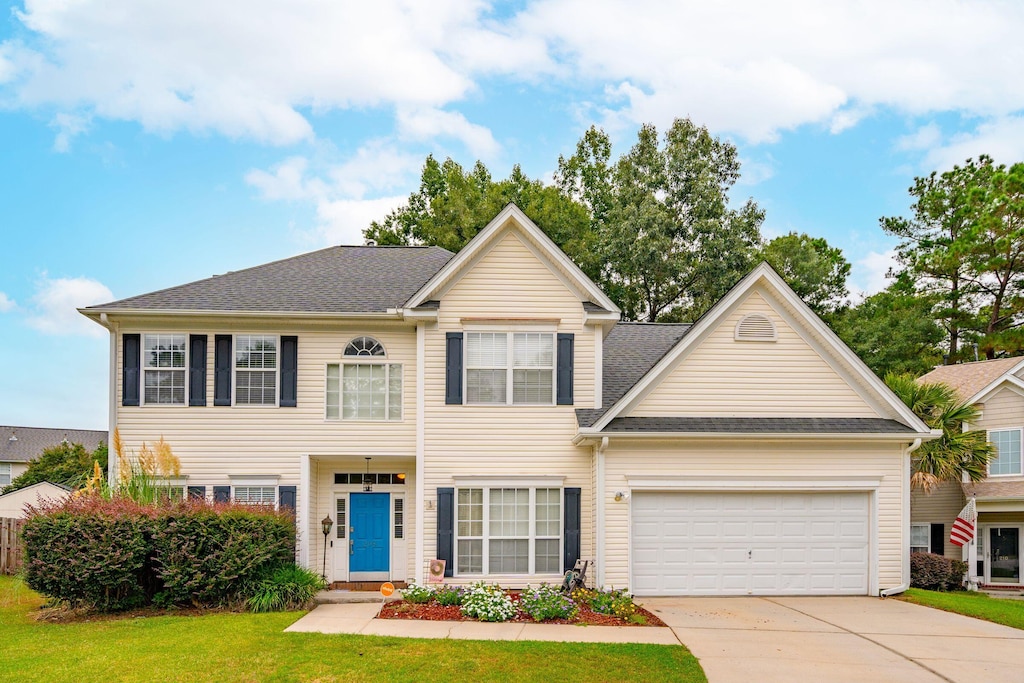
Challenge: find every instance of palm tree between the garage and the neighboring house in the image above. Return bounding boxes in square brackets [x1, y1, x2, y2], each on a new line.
[886, 373, 995, 494]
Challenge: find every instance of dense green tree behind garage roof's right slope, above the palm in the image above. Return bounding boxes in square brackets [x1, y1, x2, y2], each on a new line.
[830, 276, 945, 377]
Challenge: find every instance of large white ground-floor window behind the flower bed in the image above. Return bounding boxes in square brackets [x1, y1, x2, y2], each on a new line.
[455, 488, 562, 574]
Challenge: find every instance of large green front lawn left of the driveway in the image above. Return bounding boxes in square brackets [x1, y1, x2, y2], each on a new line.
[0, 577, 707, 683]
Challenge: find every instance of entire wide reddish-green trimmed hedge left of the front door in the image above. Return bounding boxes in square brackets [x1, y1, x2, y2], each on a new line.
[24, 497, 295, 611]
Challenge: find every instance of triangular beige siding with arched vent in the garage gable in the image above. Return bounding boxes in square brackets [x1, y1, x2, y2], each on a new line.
[629, 291, 879, 418]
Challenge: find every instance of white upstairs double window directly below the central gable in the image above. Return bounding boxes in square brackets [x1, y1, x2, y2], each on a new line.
[465, 332, 555, 404]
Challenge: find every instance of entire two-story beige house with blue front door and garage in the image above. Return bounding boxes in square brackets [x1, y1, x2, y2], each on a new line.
[82, 205, 934, 595]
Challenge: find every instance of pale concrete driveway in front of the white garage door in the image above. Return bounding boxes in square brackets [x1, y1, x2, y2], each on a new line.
[641, 597, 1024, 683]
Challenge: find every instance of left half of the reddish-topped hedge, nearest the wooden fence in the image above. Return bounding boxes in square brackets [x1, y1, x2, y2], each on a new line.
[23, 498, 156, 611]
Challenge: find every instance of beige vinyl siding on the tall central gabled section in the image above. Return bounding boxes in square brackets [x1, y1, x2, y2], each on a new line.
[421, 229, 594, 585]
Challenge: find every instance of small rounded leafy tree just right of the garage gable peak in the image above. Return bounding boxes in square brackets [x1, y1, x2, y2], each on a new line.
[761, 232, 850, 317]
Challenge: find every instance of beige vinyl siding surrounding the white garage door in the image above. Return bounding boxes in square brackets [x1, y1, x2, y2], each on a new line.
[603, 440, 908, 589]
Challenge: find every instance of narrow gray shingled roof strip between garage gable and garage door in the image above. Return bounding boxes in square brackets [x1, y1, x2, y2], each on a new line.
[602, 418, 915, 434]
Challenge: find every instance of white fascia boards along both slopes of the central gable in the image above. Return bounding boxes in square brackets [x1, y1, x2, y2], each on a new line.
[406, 204, 618, 312]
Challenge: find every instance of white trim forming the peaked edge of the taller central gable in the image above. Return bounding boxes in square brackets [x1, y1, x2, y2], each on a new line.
[406, 204, 618, 312]
